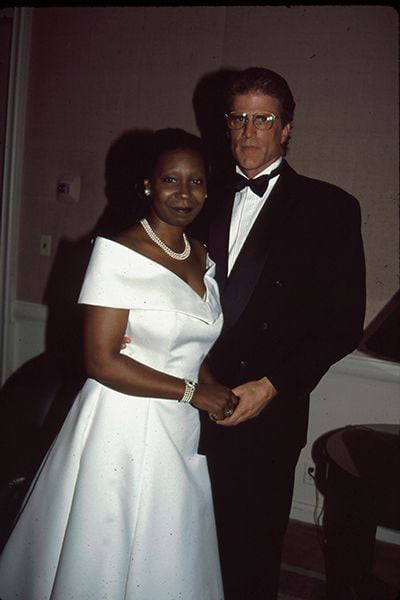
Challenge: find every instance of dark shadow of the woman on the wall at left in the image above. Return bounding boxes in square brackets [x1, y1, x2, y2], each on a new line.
[43, 131, 152, 369]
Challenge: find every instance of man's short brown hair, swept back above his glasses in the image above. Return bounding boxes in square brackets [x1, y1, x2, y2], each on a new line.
[226, 67, 296, 126]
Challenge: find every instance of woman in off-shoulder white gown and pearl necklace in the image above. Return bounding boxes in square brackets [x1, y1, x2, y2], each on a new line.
[0, 130, 235, 600]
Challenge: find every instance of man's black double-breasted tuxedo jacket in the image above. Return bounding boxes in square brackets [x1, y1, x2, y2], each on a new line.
[199, 161, 365, 454]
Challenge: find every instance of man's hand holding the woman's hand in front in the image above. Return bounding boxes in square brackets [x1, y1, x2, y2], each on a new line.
[217, 377, 278, 426]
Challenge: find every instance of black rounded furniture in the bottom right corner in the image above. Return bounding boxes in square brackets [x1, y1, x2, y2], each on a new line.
[312, 424, 400, 600]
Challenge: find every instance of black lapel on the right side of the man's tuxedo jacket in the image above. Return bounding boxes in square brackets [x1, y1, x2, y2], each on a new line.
[221, 162, 296, 331]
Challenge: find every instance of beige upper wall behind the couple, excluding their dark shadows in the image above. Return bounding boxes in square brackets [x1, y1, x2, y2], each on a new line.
[17, 6, 398, 322]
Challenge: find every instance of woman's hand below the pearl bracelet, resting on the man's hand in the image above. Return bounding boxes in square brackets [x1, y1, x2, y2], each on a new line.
[191, 382, 238, 421]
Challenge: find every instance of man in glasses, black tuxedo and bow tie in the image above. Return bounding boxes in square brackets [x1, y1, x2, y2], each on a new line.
[199, 68, 365, 600]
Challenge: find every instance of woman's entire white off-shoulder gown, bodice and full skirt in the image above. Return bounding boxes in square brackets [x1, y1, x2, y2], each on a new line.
[0, 238, 223, 600]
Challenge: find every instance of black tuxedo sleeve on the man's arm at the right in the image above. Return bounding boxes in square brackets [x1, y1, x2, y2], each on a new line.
[265, 195, 365, 397]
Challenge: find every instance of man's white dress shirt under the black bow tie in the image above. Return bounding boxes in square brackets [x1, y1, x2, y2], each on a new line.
[228, 156, 282, 276]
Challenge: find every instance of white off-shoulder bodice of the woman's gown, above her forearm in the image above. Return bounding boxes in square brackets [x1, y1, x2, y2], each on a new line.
[79, 237, 222, 379]
